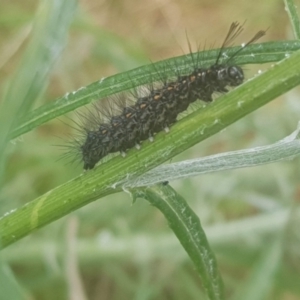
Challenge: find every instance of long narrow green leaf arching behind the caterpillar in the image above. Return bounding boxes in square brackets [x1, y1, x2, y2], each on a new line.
[10, 41, 300, 138]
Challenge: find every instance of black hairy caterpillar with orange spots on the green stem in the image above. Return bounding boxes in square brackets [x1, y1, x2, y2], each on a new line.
[67, 22, 265, 170]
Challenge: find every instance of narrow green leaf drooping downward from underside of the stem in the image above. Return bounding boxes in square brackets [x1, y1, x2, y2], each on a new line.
[133, 184, 224, 300]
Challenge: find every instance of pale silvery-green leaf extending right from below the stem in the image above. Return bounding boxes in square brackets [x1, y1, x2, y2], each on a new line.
[126, 126, 300, 188]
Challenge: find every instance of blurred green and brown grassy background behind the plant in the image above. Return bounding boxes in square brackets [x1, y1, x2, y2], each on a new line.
[0, 0, 300, 300]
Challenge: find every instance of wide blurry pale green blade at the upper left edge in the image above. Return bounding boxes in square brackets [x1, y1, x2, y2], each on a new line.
[0, 0, 77, 182]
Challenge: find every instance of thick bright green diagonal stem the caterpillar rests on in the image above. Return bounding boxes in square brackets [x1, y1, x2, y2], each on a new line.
[0, 46, 300, 247]
